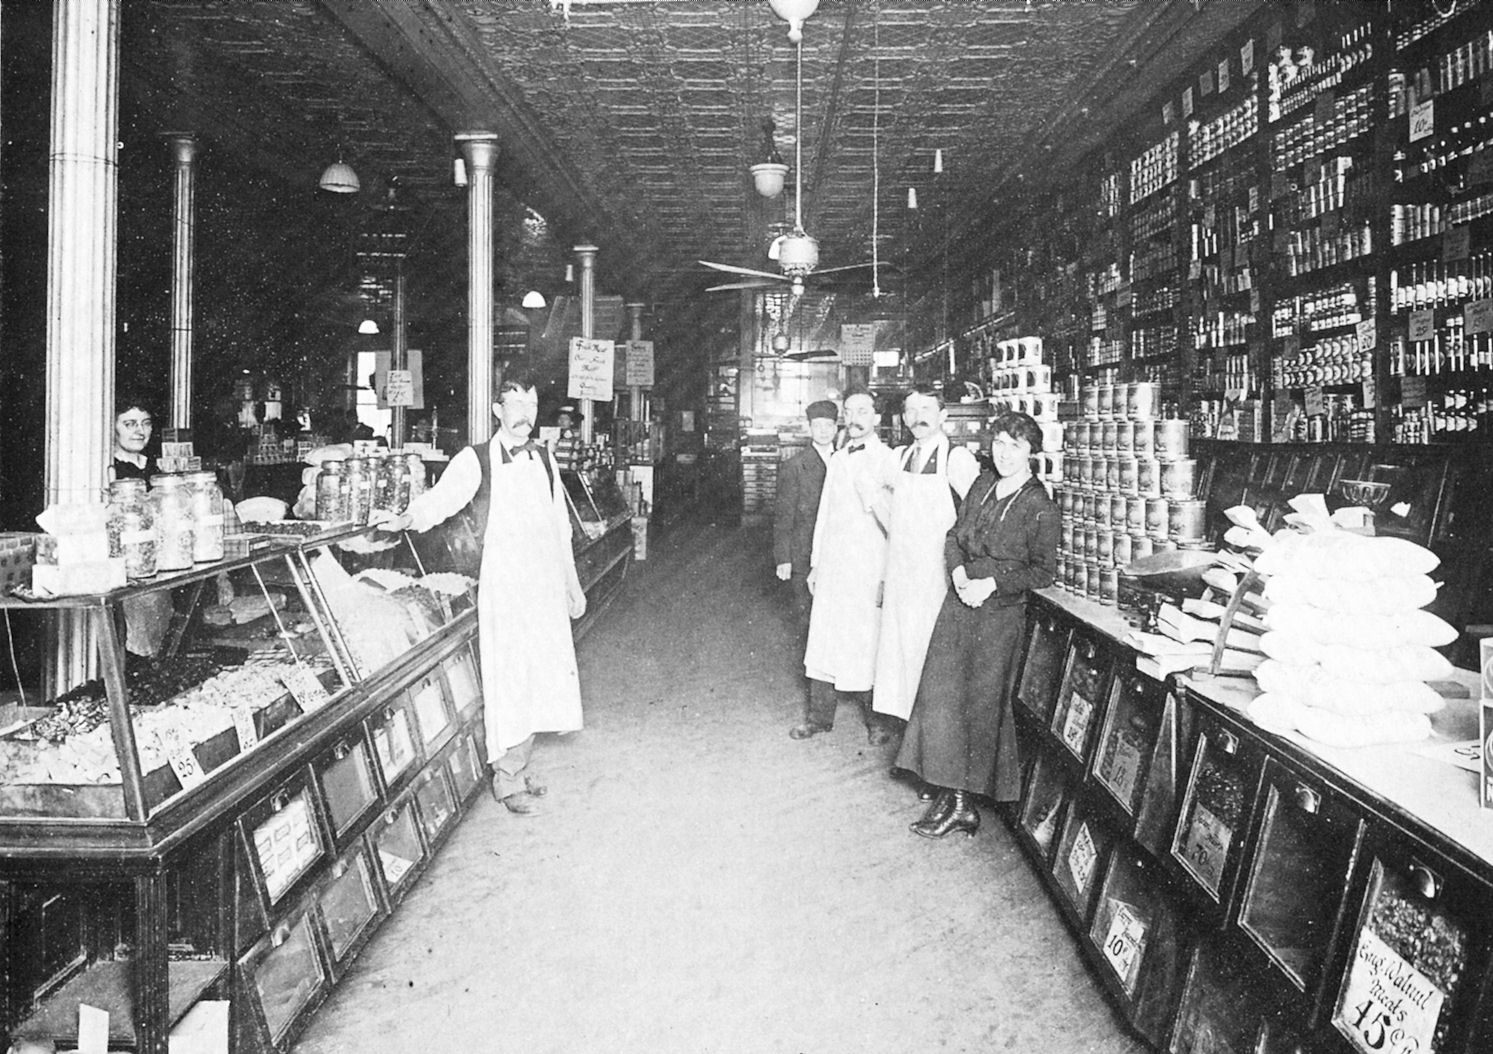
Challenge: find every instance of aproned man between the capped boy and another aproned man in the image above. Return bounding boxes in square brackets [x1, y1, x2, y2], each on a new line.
[788, 391, 897, 745]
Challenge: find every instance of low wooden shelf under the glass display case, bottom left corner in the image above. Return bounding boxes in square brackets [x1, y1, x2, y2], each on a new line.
[13, 958, 228, 1048]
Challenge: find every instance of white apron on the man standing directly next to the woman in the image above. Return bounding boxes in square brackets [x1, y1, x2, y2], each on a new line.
[872, 446, 956, 720]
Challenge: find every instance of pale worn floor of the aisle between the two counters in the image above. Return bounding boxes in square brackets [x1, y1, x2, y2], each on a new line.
[296, 523, 1141, 1054]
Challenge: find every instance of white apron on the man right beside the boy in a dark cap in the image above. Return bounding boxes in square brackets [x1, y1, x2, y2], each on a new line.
[803, 442, 896, 691]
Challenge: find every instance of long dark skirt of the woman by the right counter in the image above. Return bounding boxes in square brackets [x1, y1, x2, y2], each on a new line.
[897, 593, 1026, 802]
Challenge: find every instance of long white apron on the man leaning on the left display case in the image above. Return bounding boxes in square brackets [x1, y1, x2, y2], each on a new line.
[478, 442, 581, 758]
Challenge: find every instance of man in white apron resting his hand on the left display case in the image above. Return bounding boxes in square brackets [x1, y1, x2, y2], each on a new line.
[385, 378, 585, 815]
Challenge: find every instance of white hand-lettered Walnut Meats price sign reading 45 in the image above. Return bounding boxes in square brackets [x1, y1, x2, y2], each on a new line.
[1336, 929, 1447, 1054]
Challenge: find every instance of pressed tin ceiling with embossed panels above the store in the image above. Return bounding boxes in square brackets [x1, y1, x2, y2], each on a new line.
[124, 0, 1257, 352]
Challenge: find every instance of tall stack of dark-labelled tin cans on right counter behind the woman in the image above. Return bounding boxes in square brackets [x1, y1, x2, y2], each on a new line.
[1056, 381, 1203, 605]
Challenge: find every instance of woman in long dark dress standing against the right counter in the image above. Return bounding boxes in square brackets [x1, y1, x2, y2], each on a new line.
[897, 412, 1060, 838]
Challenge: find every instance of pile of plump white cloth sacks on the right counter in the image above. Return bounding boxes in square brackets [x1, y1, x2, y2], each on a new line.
[1248, 511, 1457, 746]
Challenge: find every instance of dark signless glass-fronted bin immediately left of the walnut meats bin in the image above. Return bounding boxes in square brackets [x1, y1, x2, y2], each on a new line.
[1239, 758, 1362, 993]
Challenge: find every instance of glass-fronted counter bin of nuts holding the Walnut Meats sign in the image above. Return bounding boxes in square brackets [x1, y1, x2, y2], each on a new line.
[1332, 849, 1493, 1054]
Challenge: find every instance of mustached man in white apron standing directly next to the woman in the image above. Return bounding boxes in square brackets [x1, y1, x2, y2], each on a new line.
[872, 388, 979, 731]
